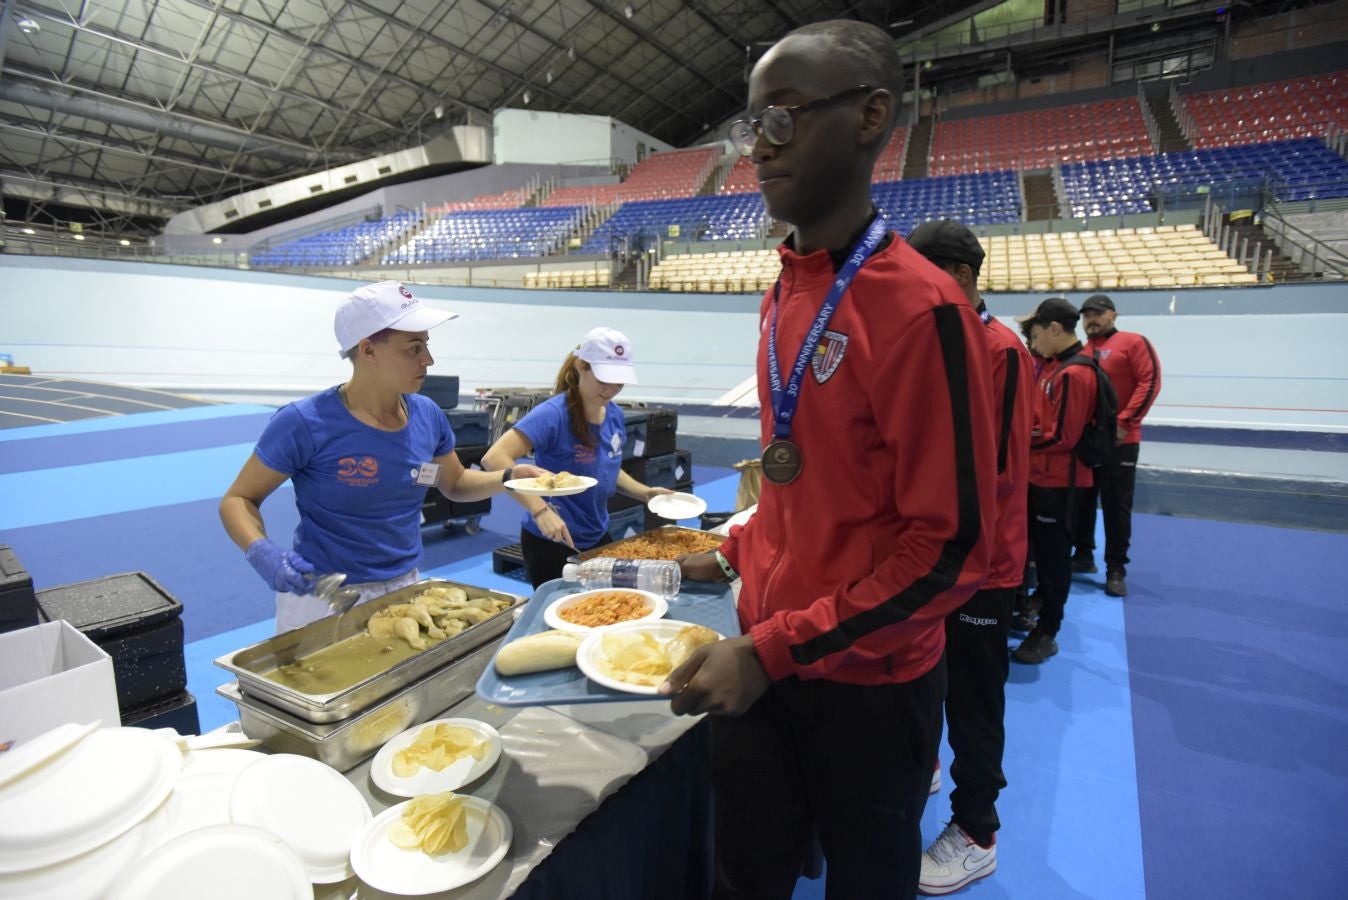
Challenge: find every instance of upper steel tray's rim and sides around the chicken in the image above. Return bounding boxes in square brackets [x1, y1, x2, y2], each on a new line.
[216, 578, 524, 725]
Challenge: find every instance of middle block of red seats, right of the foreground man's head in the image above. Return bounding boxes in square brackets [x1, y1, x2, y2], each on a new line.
[929, 97, 1155, 175]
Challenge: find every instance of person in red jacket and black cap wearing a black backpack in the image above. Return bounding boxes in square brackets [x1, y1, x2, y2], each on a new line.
[1011, 296, 1097, 664]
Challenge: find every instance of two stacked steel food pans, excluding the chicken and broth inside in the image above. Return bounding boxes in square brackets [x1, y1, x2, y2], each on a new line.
[216, 579, 524, 771]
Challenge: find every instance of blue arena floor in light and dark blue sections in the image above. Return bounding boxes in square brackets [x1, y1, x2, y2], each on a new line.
[0, 406, 1348, 900]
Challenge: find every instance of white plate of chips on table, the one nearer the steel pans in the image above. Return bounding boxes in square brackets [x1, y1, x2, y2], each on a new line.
[369, 718, 501, 796]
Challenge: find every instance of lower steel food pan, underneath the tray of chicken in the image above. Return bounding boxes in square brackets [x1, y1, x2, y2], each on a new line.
[216, 640, 500, 772]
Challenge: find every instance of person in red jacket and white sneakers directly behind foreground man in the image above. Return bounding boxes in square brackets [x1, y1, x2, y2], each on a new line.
[909, 220, 1038, 895]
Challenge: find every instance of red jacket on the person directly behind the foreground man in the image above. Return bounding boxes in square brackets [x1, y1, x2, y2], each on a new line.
[983, 312, 1039, 589]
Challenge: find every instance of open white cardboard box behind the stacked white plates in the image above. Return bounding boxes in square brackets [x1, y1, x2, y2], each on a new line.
[0, 621, 121, 742]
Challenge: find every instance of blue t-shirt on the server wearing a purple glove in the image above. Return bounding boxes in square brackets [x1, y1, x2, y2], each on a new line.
[253, 388, 454, 583]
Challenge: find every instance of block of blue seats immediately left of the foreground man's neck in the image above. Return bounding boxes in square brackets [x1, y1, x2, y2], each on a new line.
[581, 193, 767, 253]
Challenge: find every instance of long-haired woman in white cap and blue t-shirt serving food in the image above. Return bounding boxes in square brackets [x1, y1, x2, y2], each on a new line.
[483, 327, 670, 587]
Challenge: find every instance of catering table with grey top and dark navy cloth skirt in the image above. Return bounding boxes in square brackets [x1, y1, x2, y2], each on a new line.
[314, 697, 712, 900]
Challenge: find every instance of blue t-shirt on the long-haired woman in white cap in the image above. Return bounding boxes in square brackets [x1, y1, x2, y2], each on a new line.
[515, 393, 627, 548]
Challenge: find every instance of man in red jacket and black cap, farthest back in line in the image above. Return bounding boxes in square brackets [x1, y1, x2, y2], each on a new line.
[1072, 294, 1161, 597]
